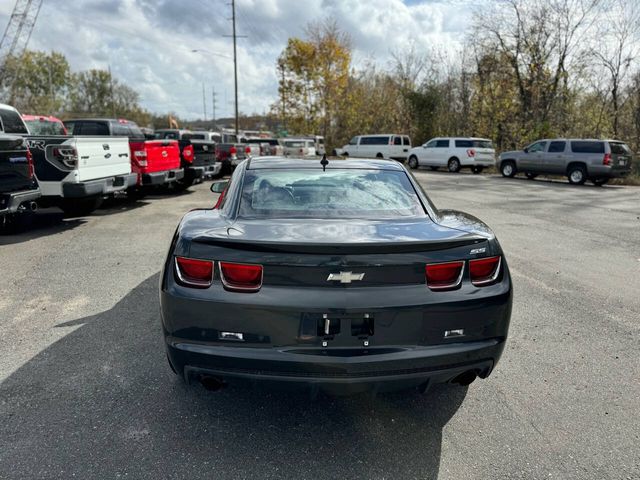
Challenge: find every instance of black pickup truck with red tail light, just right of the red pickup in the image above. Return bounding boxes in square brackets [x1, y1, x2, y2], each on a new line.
[155, 128, 222, 188]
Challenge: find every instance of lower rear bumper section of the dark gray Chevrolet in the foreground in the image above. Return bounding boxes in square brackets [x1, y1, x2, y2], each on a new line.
[166, 337, 505, 394]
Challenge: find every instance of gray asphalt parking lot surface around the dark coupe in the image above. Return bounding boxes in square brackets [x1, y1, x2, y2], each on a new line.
[0, 171, 640, 479]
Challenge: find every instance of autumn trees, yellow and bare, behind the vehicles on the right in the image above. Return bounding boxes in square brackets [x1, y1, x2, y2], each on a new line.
[271, 0, 640, 164]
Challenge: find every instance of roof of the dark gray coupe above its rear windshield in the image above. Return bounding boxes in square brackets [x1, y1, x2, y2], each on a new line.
[247, 156, 403, 171]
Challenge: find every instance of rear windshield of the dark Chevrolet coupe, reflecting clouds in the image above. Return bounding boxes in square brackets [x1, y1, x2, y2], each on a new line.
[239, 169, 426, 219]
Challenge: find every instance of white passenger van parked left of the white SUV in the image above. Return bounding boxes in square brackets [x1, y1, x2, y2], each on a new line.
[335, 133, 411, 162]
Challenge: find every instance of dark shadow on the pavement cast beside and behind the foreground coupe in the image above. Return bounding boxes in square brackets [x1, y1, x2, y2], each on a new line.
[0, 274, 467, 479]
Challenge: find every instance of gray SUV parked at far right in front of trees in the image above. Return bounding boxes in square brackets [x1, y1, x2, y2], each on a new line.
[498, 138, 633, 185]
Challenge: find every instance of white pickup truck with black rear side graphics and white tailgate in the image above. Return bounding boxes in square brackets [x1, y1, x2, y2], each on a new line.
[0, 104, 137, 215]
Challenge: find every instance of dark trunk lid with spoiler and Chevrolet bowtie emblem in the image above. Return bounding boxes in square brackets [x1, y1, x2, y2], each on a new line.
[188, 220, 487, 288]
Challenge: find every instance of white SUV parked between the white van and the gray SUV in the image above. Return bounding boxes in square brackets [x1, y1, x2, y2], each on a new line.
[408, 137, 496, 173]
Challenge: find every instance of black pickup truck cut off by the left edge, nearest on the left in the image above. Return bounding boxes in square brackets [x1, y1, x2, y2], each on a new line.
[0, 131, 40, 230]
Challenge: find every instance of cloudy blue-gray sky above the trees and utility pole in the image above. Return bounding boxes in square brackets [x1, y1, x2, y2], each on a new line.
[0, 0, 478, 119]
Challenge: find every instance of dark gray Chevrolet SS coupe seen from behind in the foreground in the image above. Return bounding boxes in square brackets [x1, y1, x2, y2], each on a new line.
[160, 157, 512, 393]
